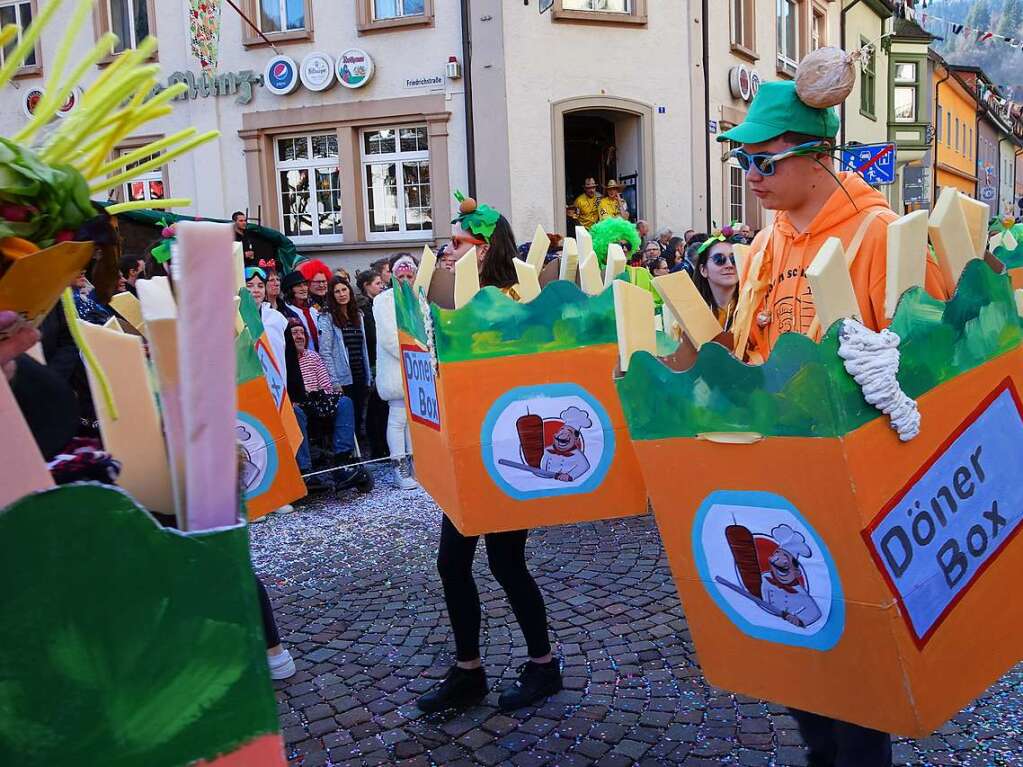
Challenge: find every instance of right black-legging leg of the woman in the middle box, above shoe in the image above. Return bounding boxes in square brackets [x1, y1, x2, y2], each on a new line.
[485, 530, 550, 658]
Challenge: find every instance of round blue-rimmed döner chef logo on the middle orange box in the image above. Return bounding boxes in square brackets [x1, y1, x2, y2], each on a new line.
[480, 384, 615, 500]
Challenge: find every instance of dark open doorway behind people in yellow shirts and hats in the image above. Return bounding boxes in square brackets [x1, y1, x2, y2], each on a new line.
[563, 109, 644, 232]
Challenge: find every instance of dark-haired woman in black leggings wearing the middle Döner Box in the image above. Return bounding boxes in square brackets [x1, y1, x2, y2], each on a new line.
[416, 192, 562, 713]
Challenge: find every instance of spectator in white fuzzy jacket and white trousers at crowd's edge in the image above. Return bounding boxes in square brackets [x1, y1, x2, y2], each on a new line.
[373, 255, 419, 490]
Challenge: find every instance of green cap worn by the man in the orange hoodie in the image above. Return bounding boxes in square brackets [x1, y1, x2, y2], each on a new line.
[717, 80, 839, 144]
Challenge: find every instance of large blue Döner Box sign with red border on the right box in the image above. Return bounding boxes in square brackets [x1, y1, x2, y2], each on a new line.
[863, 380, 1023, 646]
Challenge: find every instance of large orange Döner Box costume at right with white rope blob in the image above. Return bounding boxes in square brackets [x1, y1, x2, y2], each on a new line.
[618, 51, 1023, 737]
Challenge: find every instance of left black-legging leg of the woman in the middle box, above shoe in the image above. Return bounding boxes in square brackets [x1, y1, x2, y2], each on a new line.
[437, 514, 482, 663]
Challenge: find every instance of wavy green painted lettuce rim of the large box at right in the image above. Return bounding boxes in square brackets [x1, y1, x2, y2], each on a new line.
[618, 261, 1021, 440]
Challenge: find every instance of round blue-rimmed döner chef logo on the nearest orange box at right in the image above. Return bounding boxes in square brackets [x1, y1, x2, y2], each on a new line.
[693, 491, 845, 650]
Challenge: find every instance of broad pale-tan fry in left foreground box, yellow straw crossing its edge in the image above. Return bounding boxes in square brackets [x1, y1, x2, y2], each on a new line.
[78, 320, 174, 514]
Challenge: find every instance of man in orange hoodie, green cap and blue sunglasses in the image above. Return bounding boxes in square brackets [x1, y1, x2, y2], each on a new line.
[717, 82, 954, 362]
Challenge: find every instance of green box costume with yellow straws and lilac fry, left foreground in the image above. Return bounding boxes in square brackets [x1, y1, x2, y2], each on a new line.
[0, 0, 285, 767]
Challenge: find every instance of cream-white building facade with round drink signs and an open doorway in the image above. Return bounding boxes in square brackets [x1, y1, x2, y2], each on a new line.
[0, 0, 703, 265]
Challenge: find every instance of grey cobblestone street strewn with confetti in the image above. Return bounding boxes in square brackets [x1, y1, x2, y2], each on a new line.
[253, 468, 1023, 767]
